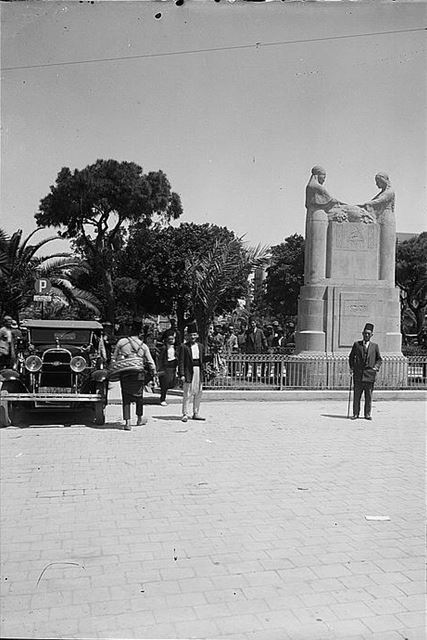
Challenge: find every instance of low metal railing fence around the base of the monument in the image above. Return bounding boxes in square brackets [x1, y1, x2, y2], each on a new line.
[204, 354, 427, 390]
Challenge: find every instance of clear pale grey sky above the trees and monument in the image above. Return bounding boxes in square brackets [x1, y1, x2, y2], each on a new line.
[0, 0, 427, 255]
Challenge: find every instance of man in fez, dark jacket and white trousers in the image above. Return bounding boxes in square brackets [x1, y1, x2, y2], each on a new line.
[178, 322, 205, 422]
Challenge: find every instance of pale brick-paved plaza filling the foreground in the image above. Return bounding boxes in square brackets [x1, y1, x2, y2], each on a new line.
[0, 401, 425, 640]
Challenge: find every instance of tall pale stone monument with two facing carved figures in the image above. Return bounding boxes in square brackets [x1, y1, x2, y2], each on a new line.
[295, 166, 403, 380]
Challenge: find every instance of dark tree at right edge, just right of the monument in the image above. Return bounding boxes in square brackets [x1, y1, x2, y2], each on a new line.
[396, 231, 427, 336]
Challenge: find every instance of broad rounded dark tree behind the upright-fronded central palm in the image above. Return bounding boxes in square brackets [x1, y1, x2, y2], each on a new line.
[118, 223, 264, 338]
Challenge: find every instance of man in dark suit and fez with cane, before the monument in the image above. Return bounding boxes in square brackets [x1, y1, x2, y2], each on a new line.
[348, 322, 382, 420]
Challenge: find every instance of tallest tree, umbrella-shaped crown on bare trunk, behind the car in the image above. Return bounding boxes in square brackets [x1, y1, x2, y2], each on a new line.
[35, 160, 182, 322]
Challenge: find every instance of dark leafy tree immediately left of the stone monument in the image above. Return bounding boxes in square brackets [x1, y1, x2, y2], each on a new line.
[264, 233, 305, 319]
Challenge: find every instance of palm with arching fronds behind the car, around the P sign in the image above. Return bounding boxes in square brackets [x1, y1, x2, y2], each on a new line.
[0, 229, 99, 318]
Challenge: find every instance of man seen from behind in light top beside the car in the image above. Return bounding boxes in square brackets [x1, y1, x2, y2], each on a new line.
[112, 320, 156, 431]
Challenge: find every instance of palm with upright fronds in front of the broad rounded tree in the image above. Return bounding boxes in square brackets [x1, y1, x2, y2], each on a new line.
[186, 237, 269, 341]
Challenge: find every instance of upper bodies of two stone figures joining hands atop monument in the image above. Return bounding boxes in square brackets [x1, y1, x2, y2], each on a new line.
[305, 166, 394, 224]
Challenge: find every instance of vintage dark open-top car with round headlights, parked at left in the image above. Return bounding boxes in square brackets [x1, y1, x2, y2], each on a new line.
[0, 320, 108, 426]
